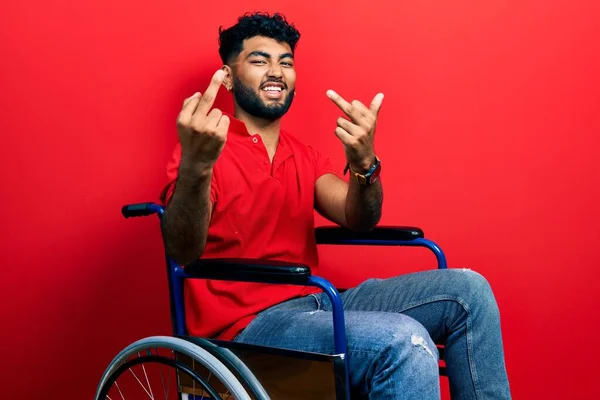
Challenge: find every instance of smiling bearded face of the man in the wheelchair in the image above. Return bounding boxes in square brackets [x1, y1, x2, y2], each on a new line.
[226, 36, 296, 121]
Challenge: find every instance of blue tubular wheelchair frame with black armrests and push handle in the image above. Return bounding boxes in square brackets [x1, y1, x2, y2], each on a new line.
[121, 203, 447, 400]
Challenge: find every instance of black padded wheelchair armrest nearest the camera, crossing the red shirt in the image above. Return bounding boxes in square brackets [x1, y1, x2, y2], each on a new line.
[184, 258, 311, 285]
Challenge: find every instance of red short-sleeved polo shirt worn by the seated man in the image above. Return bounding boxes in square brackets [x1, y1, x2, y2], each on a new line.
[163, 116, 337, 340]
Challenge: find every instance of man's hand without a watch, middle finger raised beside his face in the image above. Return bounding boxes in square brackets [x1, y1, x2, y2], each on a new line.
[177, 70, 230, 168]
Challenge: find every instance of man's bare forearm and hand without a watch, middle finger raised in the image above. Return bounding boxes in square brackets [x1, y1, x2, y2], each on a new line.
[163, 70, 230, 265]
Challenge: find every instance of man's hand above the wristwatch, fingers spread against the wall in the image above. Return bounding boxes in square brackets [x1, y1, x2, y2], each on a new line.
[327, 90, 383, 172]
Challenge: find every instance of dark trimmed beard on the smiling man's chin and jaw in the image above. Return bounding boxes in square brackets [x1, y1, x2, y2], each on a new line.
[233, 77, 294, 121]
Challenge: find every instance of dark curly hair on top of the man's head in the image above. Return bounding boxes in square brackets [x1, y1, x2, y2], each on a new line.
[219, 12, 300, 64]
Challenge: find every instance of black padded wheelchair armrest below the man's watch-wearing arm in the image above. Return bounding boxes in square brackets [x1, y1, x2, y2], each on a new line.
[315, 226, 425, 244]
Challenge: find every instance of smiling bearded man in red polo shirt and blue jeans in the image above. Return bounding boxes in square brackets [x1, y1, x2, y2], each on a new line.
[164, 13, 510, 399]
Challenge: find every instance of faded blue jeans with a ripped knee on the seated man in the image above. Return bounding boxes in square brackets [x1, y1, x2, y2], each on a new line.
[235, 269, 510, 400]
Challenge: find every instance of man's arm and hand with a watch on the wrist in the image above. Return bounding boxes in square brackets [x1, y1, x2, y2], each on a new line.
[315, 90, 383, 231]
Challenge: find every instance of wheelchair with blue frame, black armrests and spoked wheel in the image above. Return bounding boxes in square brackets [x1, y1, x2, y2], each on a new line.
[95, 203, 447, 400]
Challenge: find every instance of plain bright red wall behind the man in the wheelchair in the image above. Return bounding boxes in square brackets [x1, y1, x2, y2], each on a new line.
[0, 0, 600, 399]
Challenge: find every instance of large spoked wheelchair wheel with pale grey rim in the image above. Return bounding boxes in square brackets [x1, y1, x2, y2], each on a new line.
[95, 336, 260, 400]
